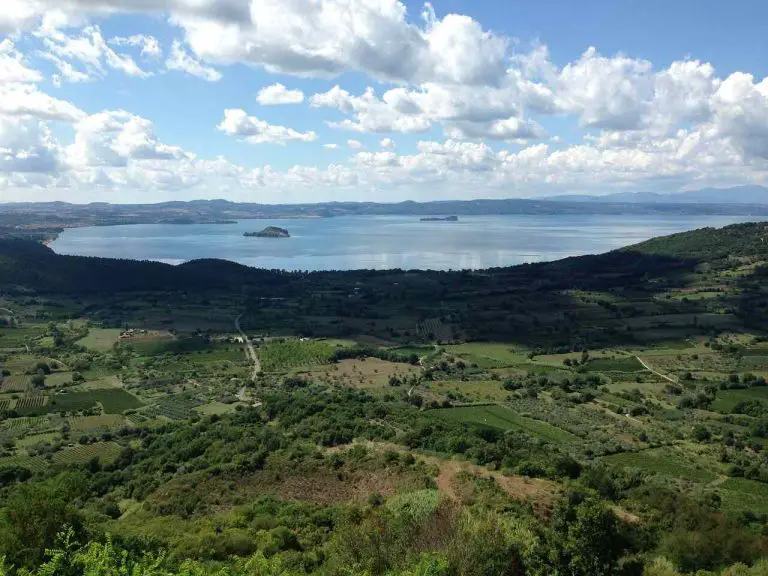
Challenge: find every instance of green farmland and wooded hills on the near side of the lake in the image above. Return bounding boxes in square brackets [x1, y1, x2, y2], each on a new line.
[0, 224, 768, 576]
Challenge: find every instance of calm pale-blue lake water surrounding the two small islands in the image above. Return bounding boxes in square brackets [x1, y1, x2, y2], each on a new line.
[52, 215, 754, 270]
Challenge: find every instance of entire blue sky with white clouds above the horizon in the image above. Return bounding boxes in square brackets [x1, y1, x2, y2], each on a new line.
[0, 0, 768, 203]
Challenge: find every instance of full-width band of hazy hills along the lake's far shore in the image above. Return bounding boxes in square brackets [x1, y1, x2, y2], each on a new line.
[0, 186, 768, 241]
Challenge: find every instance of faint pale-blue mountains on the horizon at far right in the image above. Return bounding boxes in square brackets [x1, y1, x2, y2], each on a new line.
[544, 186, 768, 204]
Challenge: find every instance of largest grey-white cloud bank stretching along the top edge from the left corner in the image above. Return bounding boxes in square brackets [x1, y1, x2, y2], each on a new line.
[0, 0, 509, 85]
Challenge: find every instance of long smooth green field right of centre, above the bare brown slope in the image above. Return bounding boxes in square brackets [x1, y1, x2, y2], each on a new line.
[433, 404, 577, 442]
